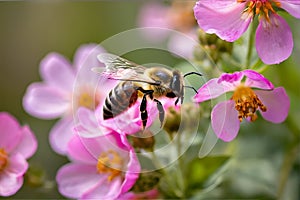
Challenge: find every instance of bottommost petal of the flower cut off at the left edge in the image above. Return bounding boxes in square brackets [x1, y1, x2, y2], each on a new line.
[0, 171, 23, 196]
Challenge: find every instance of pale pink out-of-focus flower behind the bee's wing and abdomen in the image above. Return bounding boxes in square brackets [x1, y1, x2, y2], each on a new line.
[23, 44, 112, 154]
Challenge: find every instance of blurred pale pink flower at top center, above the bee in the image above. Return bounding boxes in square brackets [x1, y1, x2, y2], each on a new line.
[138, 1, 197, 58]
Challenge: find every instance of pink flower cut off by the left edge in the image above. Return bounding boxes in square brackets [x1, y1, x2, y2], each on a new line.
[0, 112, 37, 196]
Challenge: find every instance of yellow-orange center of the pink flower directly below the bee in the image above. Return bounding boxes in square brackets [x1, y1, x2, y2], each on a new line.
[97, 150, 124, 181]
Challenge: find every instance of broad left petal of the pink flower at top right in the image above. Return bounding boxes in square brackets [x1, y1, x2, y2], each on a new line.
[194, 0, 252, 42]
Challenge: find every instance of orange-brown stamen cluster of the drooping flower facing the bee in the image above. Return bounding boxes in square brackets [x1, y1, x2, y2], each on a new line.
[232, 85, 267, 121]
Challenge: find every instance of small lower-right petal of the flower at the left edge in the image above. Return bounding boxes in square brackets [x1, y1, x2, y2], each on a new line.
[5, 153, 28, 177]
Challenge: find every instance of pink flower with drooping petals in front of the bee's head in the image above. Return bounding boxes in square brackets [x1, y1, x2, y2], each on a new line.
[194, 70, 290, 142]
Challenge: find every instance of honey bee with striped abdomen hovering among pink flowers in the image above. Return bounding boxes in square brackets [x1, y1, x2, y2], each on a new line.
[93, 53, 202, 129]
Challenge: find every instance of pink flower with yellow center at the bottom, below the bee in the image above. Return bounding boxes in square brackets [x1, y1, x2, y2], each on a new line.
[56, 132, 141, 199]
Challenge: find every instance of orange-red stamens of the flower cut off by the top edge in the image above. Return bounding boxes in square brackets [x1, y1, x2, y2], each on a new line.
[237, 0, 281, 22]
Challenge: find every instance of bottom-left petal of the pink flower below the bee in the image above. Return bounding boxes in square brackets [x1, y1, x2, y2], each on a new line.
[56, 164, 106, 199]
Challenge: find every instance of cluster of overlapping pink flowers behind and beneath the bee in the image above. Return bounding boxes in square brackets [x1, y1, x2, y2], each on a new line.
[23, 44, 174, 199]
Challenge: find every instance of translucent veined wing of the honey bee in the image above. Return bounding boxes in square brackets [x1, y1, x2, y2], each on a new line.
[93, 53, 160, 85]
